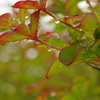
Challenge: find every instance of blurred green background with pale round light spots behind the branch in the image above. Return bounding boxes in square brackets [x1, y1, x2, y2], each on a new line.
[0, 0, 100, 100]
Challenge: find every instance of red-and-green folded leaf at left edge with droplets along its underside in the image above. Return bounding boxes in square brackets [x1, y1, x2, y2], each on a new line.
[0, 24, 31, 45]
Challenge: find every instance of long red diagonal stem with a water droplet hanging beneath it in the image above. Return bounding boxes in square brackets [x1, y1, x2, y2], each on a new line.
[43, 9, 94, 41]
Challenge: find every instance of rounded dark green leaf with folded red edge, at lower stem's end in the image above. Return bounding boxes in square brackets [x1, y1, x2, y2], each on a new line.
[59, 46, 97, 66]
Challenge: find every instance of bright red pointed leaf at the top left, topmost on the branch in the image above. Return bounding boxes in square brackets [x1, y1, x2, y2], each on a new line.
[12, 1, 41, 9]
